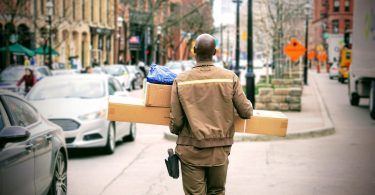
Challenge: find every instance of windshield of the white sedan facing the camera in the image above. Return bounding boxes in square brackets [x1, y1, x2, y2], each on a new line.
[28, 79, 105, 100]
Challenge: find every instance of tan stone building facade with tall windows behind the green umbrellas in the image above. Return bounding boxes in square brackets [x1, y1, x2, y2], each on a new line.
[0, 0, 116, 68]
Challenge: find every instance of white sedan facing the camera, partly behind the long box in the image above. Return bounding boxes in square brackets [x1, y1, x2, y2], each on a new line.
[26, 74, 136, 154]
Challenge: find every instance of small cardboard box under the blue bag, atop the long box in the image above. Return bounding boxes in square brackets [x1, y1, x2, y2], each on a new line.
[144, 83, 172, 108]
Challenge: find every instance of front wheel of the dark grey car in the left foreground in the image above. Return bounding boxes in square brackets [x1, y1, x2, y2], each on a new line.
[48, 151, 68, 195]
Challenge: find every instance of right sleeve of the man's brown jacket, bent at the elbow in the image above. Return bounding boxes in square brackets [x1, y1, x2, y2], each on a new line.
[233, 75, 253, 119]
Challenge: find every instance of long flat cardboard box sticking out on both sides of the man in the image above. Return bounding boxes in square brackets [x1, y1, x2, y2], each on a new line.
[107, 97, 288, 136]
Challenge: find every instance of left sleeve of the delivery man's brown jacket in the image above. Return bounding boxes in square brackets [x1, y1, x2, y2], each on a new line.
[169, 81, 185, 135]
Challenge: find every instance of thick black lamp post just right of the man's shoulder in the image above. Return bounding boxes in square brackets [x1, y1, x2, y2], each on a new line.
[246, 0, 256, 107]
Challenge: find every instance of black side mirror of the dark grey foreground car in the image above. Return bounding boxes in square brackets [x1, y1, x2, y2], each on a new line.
[0, 126, 30, 144]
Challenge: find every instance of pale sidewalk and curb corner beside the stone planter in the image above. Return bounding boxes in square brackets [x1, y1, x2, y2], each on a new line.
[164, 71, 335, 141]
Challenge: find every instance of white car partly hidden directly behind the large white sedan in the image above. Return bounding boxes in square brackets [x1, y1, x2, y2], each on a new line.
[101, 64, 130, 90]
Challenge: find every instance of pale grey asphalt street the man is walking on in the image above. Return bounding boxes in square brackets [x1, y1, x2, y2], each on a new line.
[68, 74, 375, 195]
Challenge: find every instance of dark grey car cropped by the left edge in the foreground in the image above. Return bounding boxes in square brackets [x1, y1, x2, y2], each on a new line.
[0, 90, 68, 194]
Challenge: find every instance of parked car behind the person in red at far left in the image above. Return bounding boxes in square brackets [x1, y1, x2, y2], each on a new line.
[0, 65, 52, 94]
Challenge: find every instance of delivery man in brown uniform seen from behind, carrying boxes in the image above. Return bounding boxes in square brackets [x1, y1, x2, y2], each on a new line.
[170, 34, 253, 194]
